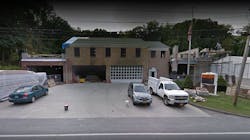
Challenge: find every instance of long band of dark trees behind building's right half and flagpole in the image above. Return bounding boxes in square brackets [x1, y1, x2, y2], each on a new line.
[123, 19, 233, 54]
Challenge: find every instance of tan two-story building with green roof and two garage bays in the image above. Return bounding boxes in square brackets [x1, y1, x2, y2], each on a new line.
[62, 37, 170, 83]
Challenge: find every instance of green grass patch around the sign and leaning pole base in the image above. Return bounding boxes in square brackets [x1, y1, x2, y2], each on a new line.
[190, 93, 250, 116]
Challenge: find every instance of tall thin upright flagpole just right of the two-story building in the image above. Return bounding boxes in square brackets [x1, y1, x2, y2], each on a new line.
[187, 7, 194, 75]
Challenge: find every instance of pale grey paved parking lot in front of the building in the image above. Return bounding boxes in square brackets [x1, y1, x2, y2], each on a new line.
[0, 83, 209, 118]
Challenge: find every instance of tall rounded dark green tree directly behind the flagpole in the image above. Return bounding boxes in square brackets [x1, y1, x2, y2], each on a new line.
[169, 19, 231, 51]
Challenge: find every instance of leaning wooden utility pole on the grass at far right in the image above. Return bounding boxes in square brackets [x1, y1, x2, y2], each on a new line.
[233, 9, 250, 106]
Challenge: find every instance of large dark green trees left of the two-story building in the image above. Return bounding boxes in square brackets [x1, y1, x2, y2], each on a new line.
[0, 1, 74, 64]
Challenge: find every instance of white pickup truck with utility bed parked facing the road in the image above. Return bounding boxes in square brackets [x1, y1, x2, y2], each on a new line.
[148, 77, 189, 106]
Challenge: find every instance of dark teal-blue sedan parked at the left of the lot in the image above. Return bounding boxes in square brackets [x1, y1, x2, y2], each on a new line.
[8, 85, 49, 104]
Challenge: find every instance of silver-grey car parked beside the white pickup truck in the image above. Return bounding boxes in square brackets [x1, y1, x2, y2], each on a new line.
[128, 82, 152, 105]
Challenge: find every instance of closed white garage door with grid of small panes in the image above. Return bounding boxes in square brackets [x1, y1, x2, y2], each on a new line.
[110, 66, 143, 83]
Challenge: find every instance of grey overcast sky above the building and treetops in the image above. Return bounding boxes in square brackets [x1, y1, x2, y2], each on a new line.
[53, 0, 250, 31]
